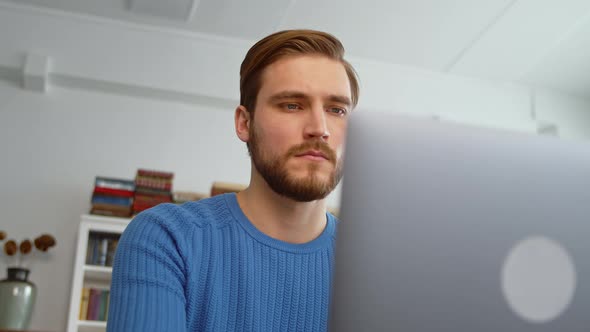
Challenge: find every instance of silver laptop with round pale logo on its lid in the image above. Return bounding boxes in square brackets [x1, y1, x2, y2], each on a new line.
[330, 111, 590, 332]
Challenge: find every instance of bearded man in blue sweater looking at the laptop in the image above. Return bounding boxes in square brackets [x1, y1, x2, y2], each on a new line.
[107, 30, 359, 332]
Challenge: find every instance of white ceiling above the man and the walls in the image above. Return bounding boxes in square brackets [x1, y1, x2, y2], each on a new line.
[0, 0, 590, 99]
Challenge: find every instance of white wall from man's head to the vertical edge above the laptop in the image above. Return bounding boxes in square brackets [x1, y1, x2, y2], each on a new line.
[353, 60, 535, 132]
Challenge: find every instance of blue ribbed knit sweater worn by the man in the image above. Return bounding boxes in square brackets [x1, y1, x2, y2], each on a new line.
[107, 194, 337, 332]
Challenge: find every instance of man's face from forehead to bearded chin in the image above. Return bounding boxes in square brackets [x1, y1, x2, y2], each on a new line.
[248, 56, 351, 202]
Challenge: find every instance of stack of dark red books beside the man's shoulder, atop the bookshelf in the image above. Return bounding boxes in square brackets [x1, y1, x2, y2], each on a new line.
[133, 169, 174, 213]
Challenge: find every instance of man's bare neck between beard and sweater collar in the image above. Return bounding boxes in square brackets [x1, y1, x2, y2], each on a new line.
[237, 170, 326, 243]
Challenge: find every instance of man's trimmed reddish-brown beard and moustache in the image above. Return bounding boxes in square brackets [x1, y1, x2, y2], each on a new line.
[248, 123, 342, 202]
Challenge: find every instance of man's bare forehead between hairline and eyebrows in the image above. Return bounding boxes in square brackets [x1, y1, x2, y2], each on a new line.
[258, 55, 351, 99]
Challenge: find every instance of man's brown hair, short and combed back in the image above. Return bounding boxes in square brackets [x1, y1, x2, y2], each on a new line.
[240, 30, 359, 114]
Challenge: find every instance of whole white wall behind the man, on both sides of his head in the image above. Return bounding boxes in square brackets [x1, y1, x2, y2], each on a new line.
[0, 6, 590, 331]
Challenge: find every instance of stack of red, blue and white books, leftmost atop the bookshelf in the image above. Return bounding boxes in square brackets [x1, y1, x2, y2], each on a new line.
[90, 176, 135, 217]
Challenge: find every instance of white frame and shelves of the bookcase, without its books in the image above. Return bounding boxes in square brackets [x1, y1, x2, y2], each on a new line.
[67, 215, 131, 332]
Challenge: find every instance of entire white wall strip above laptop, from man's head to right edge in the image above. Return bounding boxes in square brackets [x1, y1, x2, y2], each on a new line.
[351, 58, 590, 140]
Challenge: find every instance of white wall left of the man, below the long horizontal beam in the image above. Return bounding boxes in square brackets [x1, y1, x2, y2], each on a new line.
[0, 81, 250, 331]
